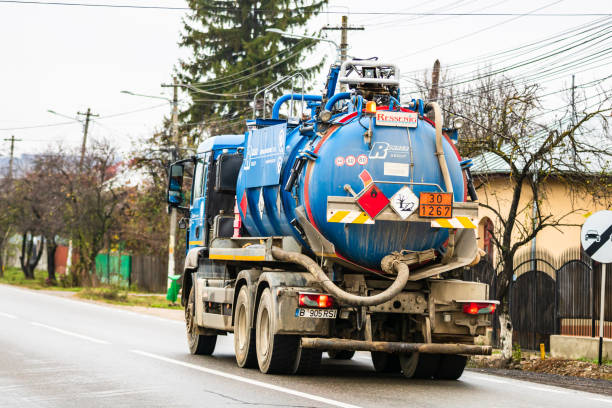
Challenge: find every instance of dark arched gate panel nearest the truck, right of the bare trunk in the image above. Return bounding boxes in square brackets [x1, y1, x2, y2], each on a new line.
[510, 258, 557, 350]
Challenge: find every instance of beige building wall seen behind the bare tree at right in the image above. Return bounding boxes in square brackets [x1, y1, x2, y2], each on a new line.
[475, 175, 612, 262]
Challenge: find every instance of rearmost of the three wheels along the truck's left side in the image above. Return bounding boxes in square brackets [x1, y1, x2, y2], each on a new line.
[255, 288, 300, 374]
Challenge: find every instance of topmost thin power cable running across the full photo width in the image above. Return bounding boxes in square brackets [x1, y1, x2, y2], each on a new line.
[0, 0, 612, 17]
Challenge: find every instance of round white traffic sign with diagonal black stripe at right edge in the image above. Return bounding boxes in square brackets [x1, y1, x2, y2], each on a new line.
[580, 210, 612, 263]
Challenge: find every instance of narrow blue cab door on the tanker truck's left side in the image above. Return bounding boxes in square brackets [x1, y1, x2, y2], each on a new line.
[188, 154, 208, 249]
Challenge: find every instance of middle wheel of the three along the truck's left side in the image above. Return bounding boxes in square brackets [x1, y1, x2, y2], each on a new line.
[234, 285, 257, 368]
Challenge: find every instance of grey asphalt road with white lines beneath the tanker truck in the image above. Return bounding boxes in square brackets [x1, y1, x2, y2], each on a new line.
[0, 285, 612, 408]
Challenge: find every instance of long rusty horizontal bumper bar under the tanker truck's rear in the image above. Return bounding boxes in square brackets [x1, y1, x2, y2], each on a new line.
[302, 337, 492, 355]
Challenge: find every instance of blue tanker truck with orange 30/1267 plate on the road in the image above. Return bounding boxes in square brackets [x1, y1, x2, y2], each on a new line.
[168, 60, 497, 379]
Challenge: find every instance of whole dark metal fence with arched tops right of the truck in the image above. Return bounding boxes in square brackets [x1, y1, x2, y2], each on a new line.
[464, 248, 612, 350]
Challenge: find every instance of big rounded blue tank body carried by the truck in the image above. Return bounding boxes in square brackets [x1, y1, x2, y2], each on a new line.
[236, 107, 465, 270]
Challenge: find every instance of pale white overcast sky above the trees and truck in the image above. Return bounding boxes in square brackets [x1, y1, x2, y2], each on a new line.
[0, 0, 612, 155]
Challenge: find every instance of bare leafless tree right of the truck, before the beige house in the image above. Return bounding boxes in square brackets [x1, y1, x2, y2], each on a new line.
[417, 67, 612, 300]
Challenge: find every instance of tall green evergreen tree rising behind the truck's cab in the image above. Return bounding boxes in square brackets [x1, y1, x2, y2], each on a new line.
[180, 0, 327, 135]
